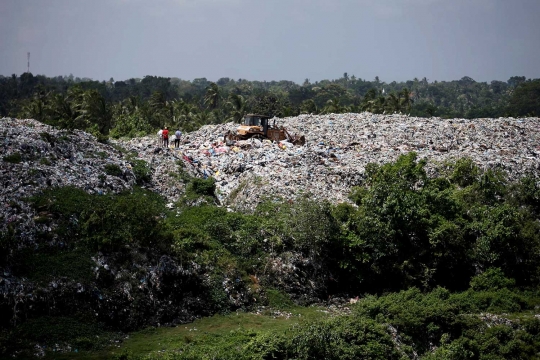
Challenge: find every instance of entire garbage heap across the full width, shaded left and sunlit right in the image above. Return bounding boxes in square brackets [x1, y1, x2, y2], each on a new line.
[4, 113, 540, 246]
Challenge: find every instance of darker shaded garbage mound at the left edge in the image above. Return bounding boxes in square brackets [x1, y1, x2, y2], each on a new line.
[0, 118, 135, 246]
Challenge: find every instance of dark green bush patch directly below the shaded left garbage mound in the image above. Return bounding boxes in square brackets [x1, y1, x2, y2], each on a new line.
[31, 187, 167, 250]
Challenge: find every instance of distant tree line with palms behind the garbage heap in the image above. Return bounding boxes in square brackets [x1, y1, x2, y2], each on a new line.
[0, 73, 540, 137]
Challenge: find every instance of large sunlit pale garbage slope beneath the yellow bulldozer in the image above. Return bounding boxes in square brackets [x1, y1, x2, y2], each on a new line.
[121, 113, 540, 210]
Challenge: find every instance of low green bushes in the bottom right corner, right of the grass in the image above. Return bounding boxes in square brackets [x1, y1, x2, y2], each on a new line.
[354, 288, 537, 359]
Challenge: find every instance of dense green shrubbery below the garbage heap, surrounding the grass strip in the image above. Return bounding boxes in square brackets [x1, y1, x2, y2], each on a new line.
[0, 153, 540, 359]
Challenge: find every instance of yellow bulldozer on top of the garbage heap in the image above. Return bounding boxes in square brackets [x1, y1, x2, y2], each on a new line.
[225, 114, 306, 145]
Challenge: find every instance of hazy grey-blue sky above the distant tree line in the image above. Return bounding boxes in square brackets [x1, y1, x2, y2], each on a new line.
[0, 0, 540, 83]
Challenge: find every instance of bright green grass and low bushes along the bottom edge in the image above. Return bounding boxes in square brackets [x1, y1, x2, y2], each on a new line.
[43, 288, 540, 360]
